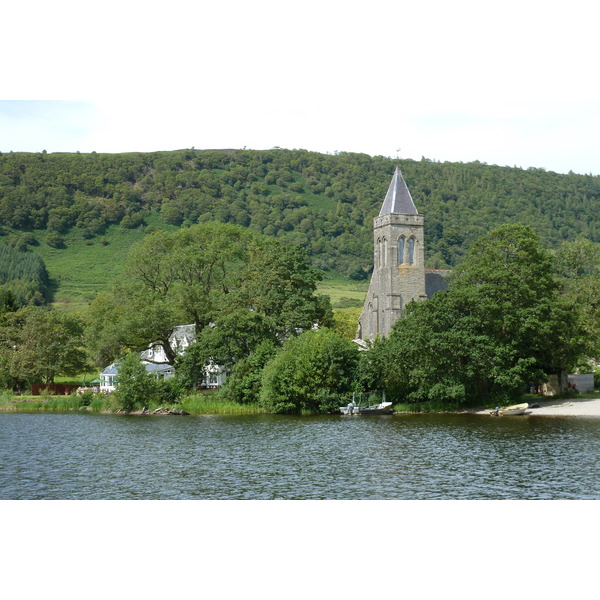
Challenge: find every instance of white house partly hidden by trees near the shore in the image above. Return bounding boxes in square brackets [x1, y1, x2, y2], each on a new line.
[100, 323, 227, 393]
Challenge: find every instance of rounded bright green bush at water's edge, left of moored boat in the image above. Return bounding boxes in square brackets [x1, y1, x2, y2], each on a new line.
[260, 329, 359, 413]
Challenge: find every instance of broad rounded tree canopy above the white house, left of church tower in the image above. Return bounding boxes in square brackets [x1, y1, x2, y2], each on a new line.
[87, 223, 331, 364]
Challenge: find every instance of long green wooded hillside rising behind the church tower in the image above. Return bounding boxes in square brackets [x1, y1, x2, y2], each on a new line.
[0, 149, 600, 309]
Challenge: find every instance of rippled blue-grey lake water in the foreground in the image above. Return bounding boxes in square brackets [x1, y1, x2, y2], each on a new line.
[0, 413, 600, 500]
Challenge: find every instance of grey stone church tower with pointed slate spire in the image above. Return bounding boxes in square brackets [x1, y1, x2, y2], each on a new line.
[358, 167, 427, 340]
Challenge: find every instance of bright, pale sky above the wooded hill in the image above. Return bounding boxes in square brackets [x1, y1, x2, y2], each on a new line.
[0, 0, 600, 175]
